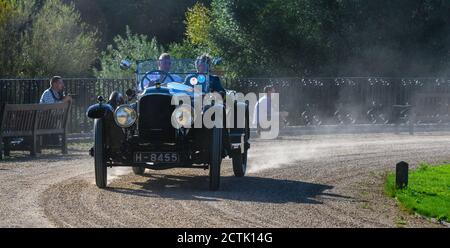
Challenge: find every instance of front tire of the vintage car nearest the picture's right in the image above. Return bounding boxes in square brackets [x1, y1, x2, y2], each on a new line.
[209, 128, 222, 191]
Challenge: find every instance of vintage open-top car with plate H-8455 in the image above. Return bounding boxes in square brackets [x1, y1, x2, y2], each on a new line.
[87, 60, 250, 190]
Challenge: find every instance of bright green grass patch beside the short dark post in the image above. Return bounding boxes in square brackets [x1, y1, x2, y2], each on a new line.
[384, 164, 450, 222]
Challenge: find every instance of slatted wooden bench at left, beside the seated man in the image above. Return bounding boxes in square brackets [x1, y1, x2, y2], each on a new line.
[0, 102, 70, 159]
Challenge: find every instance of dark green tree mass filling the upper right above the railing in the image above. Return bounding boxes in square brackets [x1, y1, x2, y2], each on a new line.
[209, 0, 450, 76]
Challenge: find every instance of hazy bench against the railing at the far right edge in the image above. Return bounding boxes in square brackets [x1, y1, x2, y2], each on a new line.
[393, 93, 450, 134]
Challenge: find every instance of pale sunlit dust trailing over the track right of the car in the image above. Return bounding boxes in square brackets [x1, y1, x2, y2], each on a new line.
[247, 134, 450, 174]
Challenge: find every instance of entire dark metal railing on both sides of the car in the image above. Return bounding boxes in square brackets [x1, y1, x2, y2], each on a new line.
[0, 77, 450, 133]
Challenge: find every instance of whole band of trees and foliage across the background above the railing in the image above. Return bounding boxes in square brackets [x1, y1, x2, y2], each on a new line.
[0, 0, 450, 77]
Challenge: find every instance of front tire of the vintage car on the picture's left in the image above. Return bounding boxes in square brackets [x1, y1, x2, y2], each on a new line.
[94, 119, 107, 189]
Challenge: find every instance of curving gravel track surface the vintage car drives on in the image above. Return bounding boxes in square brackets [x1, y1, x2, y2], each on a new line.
[0, 133, 450, 227]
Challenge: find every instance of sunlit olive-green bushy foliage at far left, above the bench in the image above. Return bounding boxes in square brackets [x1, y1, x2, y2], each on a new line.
[0, 0, 98, 77]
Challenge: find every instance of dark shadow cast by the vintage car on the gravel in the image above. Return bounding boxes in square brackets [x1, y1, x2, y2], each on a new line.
[107, 174, 349, 204]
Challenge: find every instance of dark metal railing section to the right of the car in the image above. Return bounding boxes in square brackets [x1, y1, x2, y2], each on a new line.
[228, 77, 450, 126]
